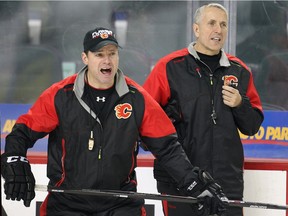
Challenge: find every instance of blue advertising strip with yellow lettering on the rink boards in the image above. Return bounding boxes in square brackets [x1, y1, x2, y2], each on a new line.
[0, 104, 288, 159]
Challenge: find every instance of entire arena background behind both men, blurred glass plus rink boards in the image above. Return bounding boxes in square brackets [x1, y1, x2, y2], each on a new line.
[0, 0, 288, 216]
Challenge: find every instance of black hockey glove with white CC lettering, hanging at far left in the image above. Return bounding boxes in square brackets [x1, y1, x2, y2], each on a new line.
[1, 154, 35, 207]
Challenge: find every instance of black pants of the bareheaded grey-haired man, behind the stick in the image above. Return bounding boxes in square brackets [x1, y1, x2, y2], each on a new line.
[157, 182, 243, 216]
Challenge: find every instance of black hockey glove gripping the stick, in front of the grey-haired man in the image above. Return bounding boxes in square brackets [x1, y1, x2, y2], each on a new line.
[187, 167, 228, 215]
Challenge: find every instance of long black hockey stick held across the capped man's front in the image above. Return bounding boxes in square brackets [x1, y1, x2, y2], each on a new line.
[35, 185, 288, 210]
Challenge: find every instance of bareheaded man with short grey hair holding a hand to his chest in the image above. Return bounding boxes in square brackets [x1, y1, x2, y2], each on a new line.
[144, 3, 264, 216]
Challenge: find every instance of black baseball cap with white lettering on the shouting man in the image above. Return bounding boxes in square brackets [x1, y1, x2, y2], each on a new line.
[83, 27, 120, 52]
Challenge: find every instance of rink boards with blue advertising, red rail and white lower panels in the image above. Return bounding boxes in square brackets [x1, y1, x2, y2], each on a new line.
[0, 104, 288, 216]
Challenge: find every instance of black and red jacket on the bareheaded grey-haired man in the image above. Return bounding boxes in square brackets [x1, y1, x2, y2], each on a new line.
[144, 43, 263, 198]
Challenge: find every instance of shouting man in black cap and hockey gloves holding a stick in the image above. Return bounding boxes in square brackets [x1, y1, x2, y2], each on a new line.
[1, 28, 227, 216]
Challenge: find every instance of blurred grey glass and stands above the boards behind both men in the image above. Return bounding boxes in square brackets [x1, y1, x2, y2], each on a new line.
[0, 0, 288, 110]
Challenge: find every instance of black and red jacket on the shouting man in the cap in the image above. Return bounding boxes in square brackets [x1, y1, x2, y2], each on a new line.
[5, 67, 195, 213]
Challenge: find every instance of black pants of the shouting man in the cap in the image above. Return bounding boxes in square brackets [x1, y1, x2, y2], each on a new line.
[40, 193, 146, 216]
